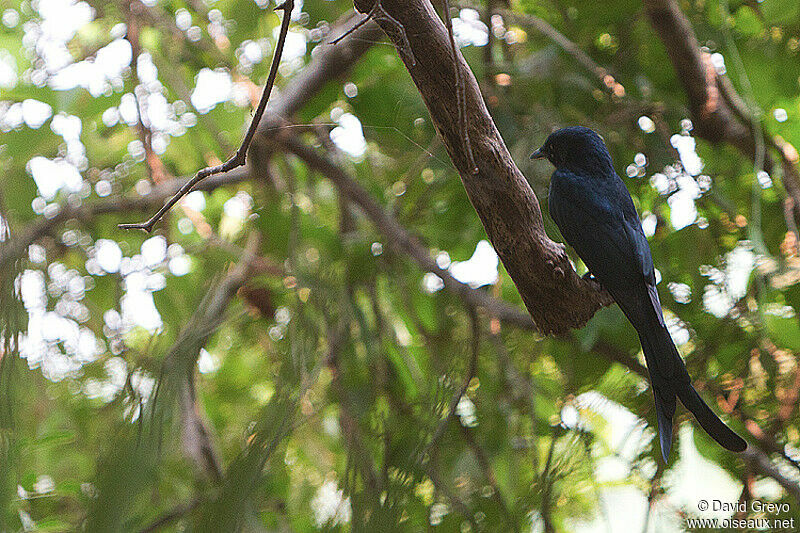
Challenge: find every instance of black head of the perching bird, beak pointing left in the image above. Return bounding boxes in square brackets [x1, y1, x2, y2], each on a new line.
[531, 126, 613, 174]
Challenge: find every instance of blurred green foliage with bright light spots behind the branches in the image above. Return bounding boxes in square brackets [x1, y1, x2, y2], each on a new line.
[0, 0, 800, 531]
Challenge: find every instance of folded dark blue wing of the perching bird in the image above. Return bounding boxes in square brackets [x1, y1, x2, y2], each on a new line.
[549, 169, 663, 320]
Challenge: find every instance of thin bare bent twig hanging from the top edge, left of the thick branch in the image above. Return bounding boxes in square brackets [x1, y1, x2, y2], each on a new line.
[119, 0, 294, 233]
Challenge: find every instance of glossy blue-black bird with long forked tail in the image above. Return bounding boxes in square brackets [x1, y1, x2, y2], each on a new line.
[531, 126, 747, 462]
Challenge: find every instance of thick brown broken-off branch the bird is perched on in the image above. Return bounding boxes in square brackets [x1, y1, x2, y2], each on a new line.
[355, 0, 611, 334]
